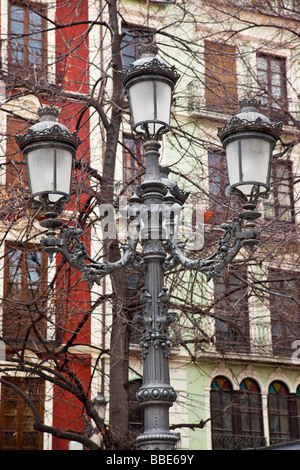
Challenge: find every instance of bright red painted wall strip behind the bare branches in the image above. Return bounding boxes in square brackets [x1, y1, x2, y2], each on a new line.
[53, 0, 91, 450]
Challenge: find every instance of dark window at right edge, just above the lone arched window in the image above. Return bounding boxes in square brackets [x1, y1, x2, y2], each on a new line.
[269, 269, 300, 356]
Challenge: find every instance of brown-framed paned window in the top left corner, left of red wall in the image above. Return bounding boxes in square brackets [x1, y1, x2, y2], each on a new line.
[8, 1, 47, 76]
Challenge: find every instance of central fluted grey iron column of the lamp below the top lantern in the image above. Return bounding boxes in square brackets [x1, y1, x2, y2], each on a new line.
[136, 140, 178, 450]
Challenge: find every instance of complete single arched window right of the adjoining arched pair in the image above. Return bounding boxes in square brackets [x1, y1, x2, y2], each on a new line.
[268, 380, 292, 444]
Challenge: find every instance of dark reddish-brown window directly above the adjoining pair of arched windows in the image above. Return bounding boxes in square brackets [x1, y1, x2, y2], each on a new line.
[214, 267, 250, 353]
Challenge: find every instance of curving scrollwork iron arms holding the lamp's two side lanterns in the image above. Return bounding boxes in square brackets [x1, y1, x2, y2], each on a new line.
[41, 187, 260, 286]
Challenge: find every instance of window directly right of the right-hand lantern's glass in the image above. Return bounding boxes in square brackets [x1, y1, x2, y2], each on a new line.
[264, 161, 295, 224]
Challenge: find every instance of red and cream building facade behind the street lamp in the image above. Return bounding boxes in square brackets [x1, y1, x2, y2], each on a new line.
[0, 0, 300, 450]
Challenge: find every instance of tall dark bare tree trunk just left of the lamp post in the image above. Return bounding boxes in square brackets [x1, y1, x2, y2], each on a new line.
[103, 0, 129, 449]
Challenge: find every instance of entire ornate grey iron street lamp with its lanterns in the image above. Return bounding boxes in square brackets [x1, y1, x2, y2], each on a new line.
[18, 46, 281, 450]
